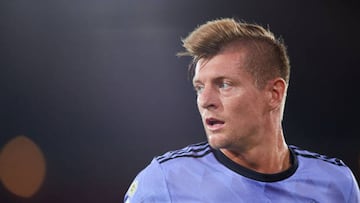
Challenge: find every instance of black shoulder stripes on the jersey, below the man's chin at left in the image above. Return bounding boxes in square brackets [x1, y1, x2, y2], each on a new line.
[155, 142, 212, 164]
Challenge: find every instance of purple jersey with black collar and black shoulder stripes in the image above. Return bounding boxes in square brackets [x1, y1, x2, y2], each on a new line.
[124, 142, 360, 203]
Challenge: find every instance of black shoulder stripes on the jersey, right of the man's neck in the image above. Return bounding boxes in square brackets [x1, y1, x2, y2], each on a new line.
[289, 145, 346, 167]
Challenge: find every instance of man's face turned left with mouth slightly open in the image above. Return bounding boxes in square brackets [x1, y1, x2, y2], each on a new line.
[193, 47, 268, 149]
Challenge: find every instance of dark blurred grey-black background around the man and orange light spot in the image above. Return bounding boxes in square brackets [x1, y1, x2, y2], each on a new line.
[0, 0, 360, 203]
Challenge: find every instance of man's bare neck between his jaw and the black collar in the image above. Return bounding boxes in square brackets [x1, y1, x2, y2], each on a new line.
[220, 130, 291, 174]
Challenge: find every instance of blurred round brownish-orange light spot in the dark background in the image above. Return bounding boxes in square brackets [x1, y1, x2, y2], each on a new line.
[0, 135, 46, 198]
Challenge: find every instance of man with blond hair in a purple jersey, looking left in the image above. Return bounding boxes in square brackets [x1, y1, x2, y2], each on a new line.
[124, 19, 360, 203]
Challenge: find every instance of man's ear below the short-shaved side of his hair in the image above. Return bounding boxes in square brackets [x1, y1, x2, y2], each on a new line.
[267, 77, 287, 109]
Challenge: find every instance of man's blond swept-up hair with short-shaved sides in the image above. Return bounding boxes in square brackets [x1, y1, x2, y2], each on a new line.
[178, 18, 290, 87]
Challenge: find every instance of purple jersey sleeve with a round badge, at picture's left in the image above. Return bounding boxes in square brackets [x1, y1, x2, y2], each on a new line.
[124, 159, 171, 203]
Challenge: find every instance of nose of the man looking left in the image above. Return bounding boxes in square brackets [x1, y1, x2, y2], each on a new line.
[197, 87, 219, 110]
